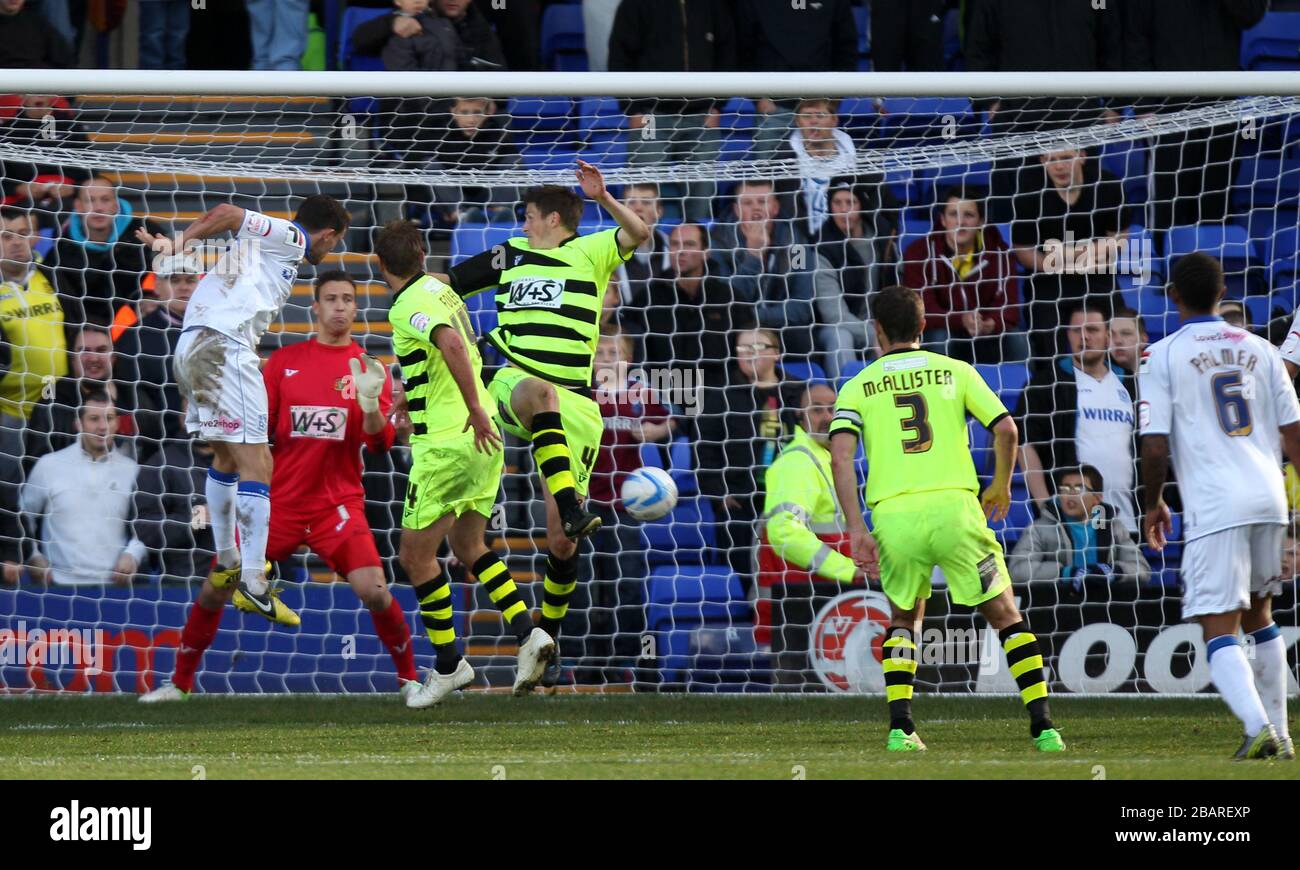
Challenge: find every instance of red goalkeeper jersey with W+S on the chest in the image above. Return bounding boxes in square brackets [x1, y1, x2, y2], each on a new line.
[263, 338, 393, 514]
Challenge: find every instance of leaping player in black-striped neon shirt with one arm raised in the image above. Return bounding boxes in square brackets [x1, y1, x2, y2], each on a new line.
[437, 160, 650, 683]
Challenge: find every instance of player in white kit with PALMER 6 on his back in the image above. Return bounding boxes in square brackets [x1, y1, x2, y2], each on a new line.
[1138, 252, 1300, 758]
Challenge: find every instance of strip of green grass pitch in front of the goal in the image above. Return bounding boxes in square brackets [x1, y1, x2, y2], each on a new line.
[0, 693, 1300, 779]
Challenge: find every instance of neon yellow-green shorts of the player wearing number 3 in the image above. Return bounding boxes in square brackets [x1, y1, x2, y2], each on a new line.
[871, 489, 1011, 610]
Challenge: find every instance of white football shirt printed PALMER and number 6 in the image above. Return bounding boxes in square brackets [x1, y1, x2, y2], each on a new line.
[1138, 317, 1300, 541]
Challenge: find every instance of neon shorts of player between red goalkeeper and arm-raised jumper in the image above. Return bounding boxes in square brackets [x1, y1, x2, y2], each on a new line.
[402, 429, 506, 529]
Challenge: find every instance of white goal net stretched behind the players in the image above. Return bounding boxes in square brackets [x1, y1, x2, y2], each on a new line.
[0, 73, 1300, 693]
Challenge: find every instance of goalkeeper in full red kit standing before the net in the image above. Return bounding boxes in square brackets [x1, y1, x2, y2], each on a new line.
[140, 272, 420, 704]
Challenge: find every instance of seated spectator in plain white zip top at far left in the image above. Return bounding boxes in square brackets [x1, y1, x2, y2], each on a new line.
[21, 390, 146, 585]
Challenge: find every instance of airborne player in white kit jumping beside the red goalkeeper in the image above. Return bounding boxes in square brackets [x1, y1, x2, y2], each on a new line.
[138, 194, 350, 624]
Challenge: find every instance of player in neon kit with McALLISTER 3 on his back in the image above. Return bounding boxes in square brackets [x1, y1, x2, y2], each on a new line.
[831, 287, 1065, 752]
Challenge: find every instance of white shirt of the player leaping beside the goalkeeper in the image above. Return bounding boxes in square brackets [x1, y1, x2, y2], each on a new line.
[185, 208, 309, 351]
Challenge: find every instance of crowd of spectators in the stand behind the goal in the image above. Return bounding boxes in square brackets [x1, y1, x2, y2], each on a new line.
[0, 0, 1300, 686]
